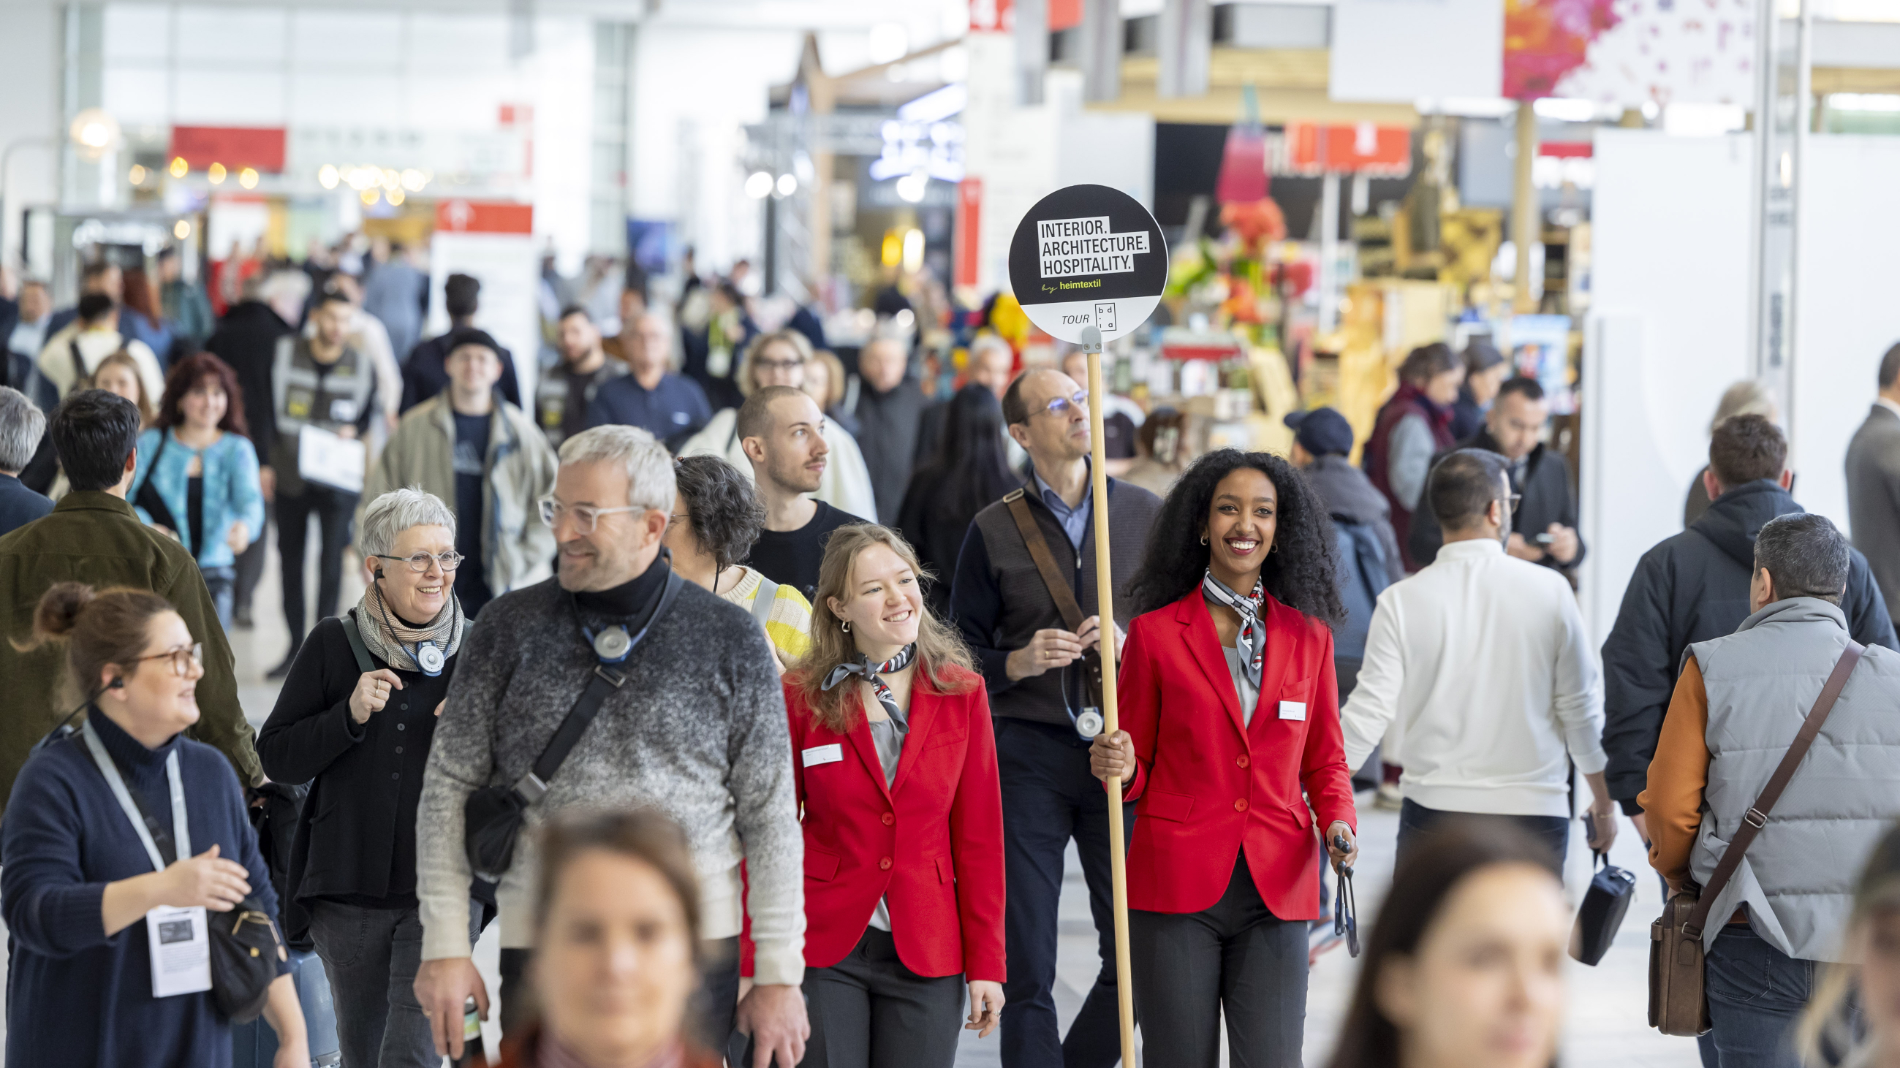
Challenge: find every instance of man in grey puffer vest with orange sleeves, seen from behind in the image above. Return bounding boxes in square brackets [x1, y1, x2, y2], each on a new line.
[1636, 511, 1900, 1068]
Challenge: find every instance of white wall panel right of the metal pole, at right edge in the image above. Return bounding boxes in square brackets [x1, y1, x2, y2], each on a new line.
[1794, 135, 1900, 530]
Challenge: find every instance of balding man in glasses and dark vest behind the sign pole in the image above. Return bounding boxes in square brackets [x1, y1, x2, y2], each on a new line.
[950, 369, 1161, 1068]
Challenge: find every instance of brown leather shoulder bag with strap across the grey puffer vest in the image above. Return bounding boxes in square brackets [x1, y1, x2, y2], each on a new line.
[1649, 640, 1866, 1038]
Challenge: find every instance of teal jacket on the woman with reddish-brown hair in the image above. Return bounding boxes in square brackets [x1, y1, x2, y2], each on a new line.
[125, 429, 264, 568]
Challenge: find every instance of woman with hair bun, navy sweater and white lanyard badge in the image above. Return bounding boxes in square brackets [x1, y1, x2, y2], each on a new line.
[0, 582, 310, 1068]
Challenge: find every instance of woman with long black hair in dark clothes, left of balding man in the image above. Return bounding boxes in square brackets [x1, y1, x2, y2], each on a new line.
[897, 381, 1020, 620]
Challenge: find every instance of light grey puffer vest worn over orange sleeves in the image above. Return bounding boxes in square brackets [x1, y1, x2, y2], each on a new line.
[1687, 597, 1900, 960]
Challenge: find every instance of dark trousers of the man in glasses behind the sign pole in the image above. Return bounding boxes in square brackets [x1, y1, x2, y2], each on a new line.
[996, 716, 1134, 1068]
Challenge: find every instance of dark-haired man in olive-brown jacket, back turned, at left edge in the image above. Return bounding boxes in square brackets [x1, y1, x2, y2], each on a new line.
[0, 390, 262, 805]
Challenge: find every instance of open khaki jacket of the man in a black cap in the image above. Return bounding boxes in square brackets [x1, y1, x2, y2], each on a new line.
[357, 390, 561, 597]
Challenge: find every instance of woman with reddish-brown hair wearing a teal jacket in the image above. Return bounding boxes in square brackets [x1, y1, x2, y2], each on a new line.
[127, 352, 264, 627]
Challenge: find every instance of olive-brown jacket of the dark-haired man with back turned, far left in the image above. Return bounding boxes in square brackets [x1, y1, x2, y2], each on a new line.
[0, 490, 262, 806]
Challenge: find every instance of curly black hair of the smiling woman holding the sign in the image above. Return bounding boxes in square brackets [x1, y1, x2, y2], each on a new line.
[1129, 448, 1345, 625]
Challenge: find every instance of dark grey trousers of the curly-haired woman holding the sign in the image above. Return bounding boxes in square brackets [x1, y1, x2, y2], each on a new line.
[1129, 853, 1307, 1068]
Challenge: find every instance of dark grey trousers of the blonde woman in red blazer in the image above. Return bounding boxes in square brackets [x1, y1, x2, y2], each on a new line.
[798, 927, 963, 1068]
